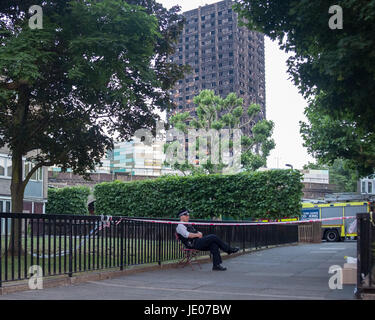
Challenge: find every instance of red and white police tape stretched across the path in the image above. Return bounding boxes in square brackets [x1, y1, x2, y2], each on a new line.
[123, 216, 356, 226]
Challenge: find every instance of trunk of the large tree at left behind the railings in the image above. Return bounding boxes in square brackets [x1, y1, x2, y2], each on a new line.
[8, 151, 25, 256]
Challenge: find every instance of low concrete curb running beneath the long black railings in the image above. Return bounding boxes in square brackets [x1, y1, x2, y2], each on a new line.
[0, 242, 298, 295]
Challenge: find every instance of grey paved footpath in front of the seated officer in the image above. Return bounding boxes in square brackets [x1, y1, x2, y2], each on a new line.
[0, 241, 357, 300]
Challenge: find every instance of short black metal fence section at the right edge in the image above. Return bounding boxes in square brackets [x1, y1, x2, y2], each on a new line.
[357, 213, 375, 295]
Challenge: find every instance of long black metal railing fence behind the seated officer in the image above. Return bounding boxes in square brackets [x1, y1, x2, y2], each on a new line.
[0, 213, 298, 286]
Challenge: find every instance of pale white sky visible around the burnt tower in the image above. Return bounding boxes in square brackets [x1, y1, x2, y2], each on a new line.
[157, 0, 314, 169]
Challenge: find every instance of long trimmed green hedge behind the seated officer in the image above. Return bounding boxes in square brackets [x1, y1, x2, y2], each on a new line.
[94, 170, 303, 219]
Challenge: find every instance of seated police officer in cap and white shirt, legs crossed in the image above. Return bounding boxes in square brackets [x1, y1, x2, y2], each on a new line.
[176, 209, 239, 271]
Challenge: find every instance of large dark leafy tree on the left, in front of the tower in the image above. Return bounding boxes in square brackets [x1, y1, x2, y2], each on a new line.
[0, 0, 186, 255]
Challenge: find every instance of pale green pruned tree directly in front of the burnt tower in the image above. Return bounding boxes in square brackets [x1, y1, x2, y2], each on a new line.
[165, 90, 275, 174]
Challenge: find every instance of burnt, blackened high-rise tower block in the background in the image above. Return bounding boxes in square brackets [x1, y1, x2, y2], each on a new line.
[171, 0, 266, 134]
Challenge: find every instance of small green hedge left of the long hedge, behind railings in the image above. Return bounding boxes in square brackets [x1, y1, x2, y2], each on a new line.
[46, 187, 90, 215]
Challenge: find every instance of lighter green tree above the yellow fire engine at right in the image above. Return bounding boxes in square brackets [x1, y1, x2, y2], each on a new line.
[300, 96, 375, 177]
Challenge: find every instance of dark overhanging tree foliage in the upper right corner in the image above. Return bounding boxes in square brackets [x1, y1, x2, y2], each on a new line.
[235, 0, 375, 133]
